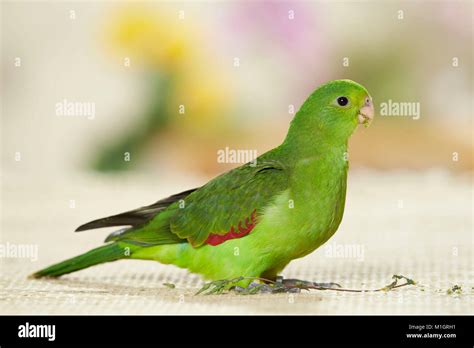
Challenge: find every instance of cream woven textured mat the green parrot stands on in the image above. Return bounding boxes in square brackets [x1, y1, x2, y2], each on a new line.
[0, 170, 474, 314]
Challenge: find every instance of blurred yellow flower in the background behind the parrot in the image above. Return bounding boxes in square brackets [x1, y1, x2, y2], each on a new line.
[103, 4, 232, 133]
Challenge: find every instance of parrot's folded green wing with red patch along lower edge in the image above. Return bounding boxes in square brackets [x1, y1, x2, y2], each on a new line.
[103, 156, 288, 247]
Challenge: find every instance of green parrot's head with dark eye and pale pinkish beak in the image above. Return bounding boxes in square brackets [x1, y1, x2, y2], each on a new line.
[289, 80, 374, 146]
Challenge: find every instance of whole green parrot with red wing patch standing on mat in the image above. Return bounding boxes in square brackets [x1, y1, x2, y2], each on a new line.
[32, 80, 374, 291]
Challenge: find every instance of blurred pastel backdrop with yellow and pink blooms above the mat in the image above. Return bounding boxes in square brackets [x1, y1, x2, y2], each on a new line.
[2, 2, 473, 176]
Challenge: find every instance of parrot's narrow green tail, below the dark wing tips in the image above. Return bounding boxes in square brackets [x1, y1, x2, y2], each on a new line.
[30, 243, 131, 278]
